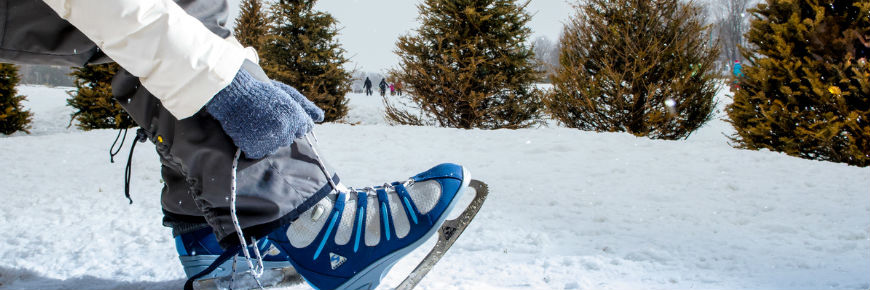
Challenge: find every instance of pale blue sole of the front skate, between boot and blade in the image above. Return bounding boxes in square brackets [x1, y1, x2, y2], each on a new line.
[334, 167, 471, 290]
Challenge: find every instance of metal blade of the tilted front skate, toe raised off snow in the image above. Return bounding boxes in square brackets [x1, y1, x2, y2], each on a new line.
[396, 179, 489, 290]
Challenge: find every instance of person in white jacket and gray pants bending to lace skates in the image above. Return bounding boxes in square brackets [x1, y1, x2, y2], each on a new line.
[0, 0, 470, 289]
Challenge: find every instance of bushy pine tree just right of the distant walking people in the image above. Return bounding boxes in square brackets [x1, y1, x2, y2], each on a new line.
[384, 0, 543, 129]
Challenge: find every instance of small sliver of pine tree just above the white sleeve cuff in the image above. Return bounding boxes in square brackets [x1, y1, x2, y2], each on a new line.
[233, 0, 269, 52]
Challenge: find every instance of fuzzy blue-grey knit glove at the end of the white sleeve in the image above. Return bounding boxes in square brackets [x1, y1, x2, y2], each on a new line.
[206, 69, 314, 159]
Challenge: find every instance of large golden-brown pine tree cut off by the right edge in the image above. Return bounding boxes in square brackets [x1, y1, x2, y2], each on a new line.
[727, 0, 870, 166]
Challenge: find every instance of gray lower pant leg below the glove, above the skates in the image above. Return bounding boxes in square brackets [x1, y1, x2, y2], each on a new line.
[112, 69, 339, 245]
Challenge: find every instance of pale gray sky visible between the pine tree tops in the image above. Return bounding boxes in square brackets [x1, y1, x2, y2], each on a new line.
[229, 0, 573, 72]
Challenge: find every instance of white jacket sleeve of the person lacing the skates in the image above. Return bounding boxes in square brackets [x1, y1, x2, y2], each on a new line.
[43, 0, 258, 119]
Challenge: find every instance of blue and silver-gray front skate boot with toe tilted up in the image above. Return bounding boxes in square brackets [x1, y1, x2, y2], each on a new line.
[268, 164, 470, 290]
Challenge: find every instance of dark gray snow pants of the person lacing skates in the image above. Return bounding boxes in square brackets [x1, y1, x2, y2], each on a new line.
[0, 0, 339, 246]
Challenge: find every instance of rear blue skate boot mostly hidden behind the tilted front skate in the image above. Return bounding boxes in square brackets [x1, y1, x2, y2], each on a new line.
[175, 227, 301, 289]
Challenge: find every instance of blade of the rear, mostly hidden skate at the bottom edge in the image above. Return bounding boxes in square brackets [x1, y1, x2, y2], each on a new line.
[193, 267, 305, 290]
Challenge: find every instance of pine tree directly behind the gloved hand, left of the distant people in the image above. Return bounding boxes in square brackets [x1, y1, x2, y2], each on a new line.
[260, 0, 351, 122]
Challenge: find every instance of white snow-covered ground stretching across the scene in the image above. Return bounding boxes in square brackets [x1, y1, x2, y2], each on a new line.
[0, 87, 870, 289]
